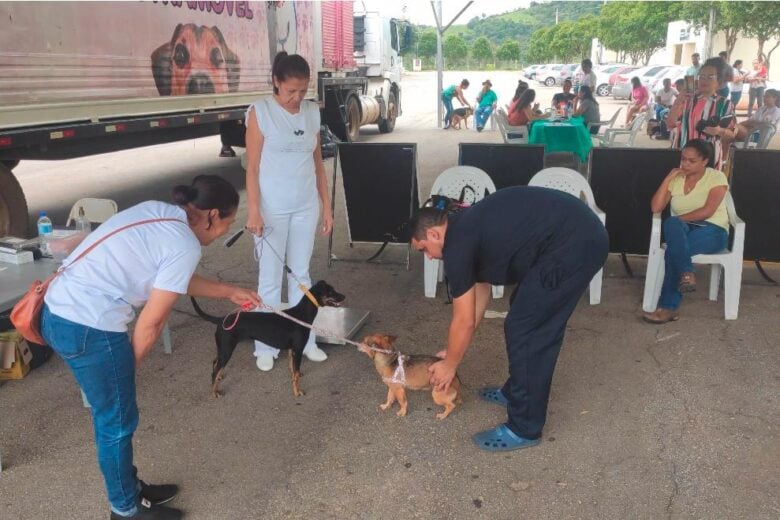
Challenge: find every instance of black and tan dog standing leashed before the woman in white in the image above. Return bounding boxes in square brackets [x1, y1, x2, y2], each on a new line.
[190, 280, 345, 397]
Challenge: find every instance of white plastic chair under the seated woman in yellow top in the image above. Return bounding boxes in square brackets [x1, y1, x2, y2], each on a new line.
[642, 192, 745, 320]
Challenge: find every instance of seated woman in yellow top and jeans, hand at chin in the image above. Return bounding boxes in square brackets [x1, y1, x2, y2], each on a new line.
[644, 139, 729, 324]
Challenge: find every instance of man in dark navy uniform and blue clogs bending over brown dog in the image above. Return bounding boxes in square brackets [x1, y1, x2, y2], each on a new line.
[410, 187, 609, 451]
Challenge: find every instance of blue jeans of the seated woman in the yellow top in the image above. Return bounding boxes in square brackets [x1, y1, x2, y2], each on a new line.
[658, 217, 729, 310]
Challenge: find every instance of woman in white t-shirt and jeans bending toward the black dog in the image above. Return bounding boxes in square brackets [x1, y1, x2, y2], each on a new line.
[41, 175, 260, 519]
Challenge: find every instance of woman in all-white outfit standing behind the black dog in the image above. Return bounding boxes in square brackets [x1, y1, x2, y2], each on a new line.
[246, 52, 333, 371]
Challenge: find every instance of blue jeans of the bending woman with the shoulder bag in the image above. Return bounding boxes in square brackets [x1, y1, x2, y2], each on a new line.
[41, 306, 139, 516]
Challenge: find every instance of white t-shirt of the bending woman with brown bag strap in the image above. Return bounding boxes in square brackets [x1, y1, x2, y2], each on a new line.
[45, 201, 201, 332]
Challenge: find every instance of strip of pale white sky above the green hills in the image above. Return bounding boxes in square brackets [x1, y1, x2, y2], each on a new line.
[366, 0, 531, 26]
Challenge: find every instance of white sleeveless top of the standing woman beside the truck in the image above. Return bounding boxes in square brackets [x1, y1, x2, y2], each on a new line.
[252, 96, 320, 214]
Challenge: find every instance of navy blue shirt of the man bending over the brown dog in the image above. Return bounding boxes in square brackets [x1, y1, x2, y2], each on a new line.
[442, 186, 606, 298]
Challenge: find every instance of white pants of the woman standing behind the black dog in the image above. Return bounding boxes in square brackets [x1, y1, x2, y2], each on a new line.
[255, 205, 320, 358]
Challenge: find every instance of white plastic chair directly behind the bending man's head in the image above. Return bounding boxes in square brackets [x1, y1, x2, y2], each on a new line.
[423, 166, 504, 298]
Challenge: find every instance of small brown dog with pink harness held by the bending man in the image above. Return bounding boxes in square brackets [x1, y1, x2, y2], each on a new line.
[359, 334, 463, 419]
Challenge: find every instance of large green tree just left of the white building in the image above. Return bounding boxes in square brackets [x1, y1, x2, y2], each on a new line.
[597, 2, 682, 64]
